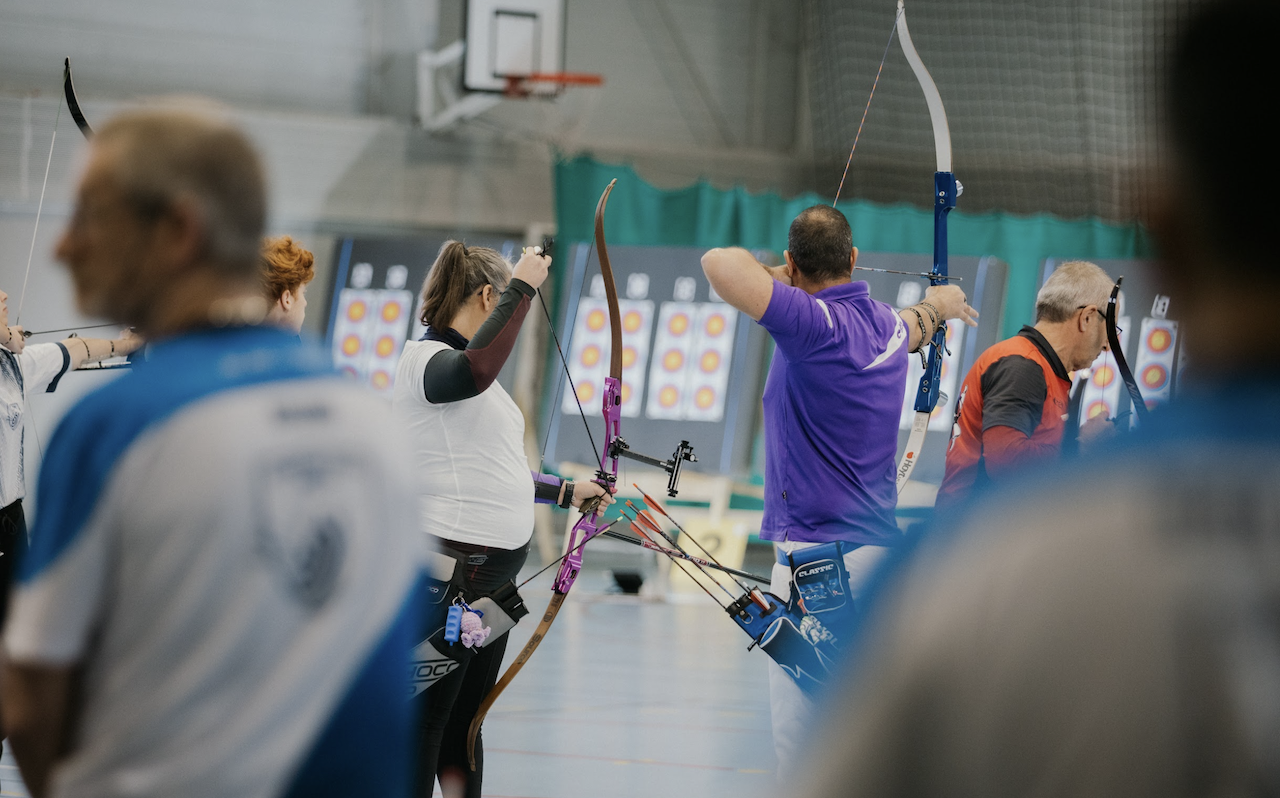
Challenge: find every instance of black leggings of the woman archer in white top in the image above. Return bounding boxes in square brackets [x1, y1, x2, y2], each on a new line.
[417, 541, 529, 798]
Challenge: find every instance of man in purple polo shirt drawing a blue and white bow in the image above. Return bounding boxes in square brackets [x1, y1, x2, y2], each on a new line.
[703, 211, 978, 783]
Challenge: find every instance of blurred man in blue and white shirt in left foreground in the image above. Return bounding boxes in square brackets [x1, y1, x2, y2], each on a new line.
[3, 110, 422, 797]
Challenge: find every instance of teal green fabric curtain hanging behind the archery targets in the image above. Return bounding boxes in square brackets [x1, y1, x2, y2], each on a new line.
[556, 156, 1152, 337]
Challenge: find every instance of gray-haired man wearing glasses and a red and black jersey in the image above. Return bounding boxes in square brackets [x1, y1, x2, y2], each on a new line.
[937, 260, 1115, 512]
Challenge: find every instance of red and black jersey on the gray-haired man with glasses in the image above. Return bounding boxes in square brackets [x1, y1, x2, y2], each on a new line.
[938, 327, 1071, 506]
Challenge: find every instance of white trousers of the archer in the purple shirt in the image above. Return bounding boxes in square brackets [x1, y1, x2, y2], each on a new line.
[769, 541, 888, 784]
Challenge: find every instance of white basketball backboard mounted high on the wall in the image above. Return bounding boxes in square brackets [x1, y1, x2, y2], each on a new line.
[462, 0, 564, 92]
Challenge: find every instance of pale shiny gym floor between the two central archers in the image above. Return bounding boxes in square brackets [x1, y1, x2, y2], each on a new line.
[460, 571, 774, 798]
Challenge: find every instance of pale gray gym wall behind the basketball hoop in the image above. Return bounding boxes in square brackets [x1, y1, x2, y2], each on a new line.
[0, 0, 805, 499]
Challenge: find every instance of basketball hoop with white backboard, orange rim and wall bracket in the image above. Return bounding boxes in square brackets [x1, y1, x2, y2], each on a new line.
[417, 0, 604, 131]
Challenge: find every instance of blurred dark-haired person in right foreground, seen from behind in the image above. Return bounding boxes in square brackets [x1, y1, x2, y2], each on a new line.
[800, 0, 1280, 798]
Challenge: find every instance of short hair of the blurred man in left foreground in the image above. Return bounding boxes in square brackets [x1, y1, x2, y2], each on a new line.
[93, 108, 266, 278]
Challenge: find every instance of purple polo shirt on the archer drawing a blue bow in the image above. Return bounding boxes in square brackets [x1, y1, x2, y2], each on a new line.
[759, 281, 911, 546]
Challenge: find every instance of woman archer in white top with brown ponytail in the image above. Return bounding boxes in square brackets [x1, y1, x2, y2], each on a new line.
[392, 241, 612, 798]
